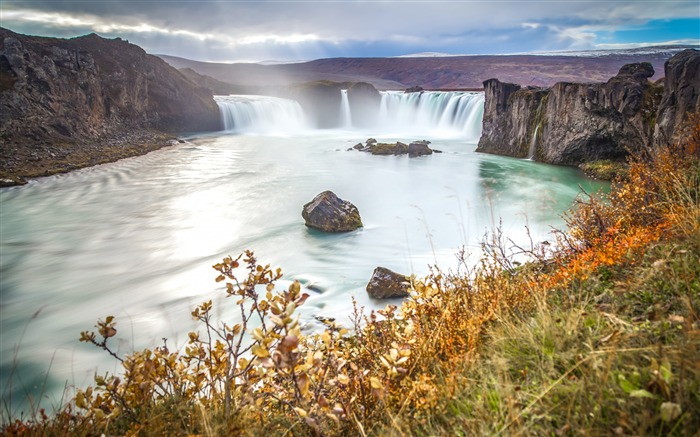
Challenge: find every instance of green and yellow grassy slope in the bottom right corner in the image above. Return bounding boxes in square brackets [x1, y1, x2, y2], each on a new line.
[404, 234, 700, 435]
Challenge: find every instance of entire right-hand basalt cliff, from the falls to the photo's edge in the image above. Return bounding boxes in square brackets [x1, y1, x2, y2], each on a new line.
[477, 50, 700, 165]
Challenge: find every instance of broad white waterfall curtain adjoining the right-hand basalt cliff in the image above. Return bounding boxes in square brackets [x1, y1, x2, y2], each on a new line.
[378, 91, 484, 140]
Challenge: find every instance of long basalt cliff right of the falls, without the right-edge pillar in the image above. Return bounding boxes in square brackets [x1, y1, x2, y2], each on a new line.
[477, 63, 658, 165]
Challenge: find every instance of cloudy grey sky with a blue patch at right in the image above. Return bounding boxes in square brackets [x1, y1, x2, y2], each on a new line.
[0, 0, 700, 62]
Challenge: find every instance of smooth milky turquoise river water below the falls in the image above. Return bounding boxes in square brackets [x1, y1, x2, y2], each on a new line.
[0, 130, 602, 412]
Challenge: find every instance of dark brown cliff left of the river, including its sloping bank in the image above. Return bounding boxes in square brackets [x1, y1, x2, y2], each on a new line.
[0, 28, 220, 182]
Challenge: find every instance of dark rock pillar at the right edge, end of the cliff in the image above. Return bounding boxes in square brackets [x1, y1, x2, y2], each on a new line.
[654, 50, 700, 145]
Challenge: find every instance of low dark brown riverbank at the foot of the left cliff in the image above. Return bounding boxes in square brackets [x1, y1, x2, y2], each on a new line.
[0, 130, 178, 187]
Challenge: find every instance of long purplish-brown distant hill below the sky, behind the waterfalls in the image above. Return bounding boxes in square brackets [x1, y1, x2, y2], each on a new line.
[159, 46, 688, 89]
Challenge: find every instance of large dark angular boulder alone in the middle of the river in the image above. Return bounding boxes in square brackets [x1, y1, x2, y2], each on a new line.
[301, 191, 362, 232]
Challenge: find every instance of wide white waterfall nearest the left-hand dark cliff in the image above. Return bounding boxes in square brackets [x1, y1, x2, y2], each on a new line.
[214, 95, 308, 134]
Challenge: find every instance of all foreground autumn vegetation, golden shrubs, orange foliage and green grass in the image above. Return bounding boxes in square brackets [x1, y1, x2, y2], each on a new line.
[3, 118, 700, 436]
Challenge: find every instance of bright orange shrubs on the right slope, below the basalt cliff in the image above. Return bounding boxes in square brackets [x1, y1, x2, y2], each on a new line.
[543, 115, 700, 288]
